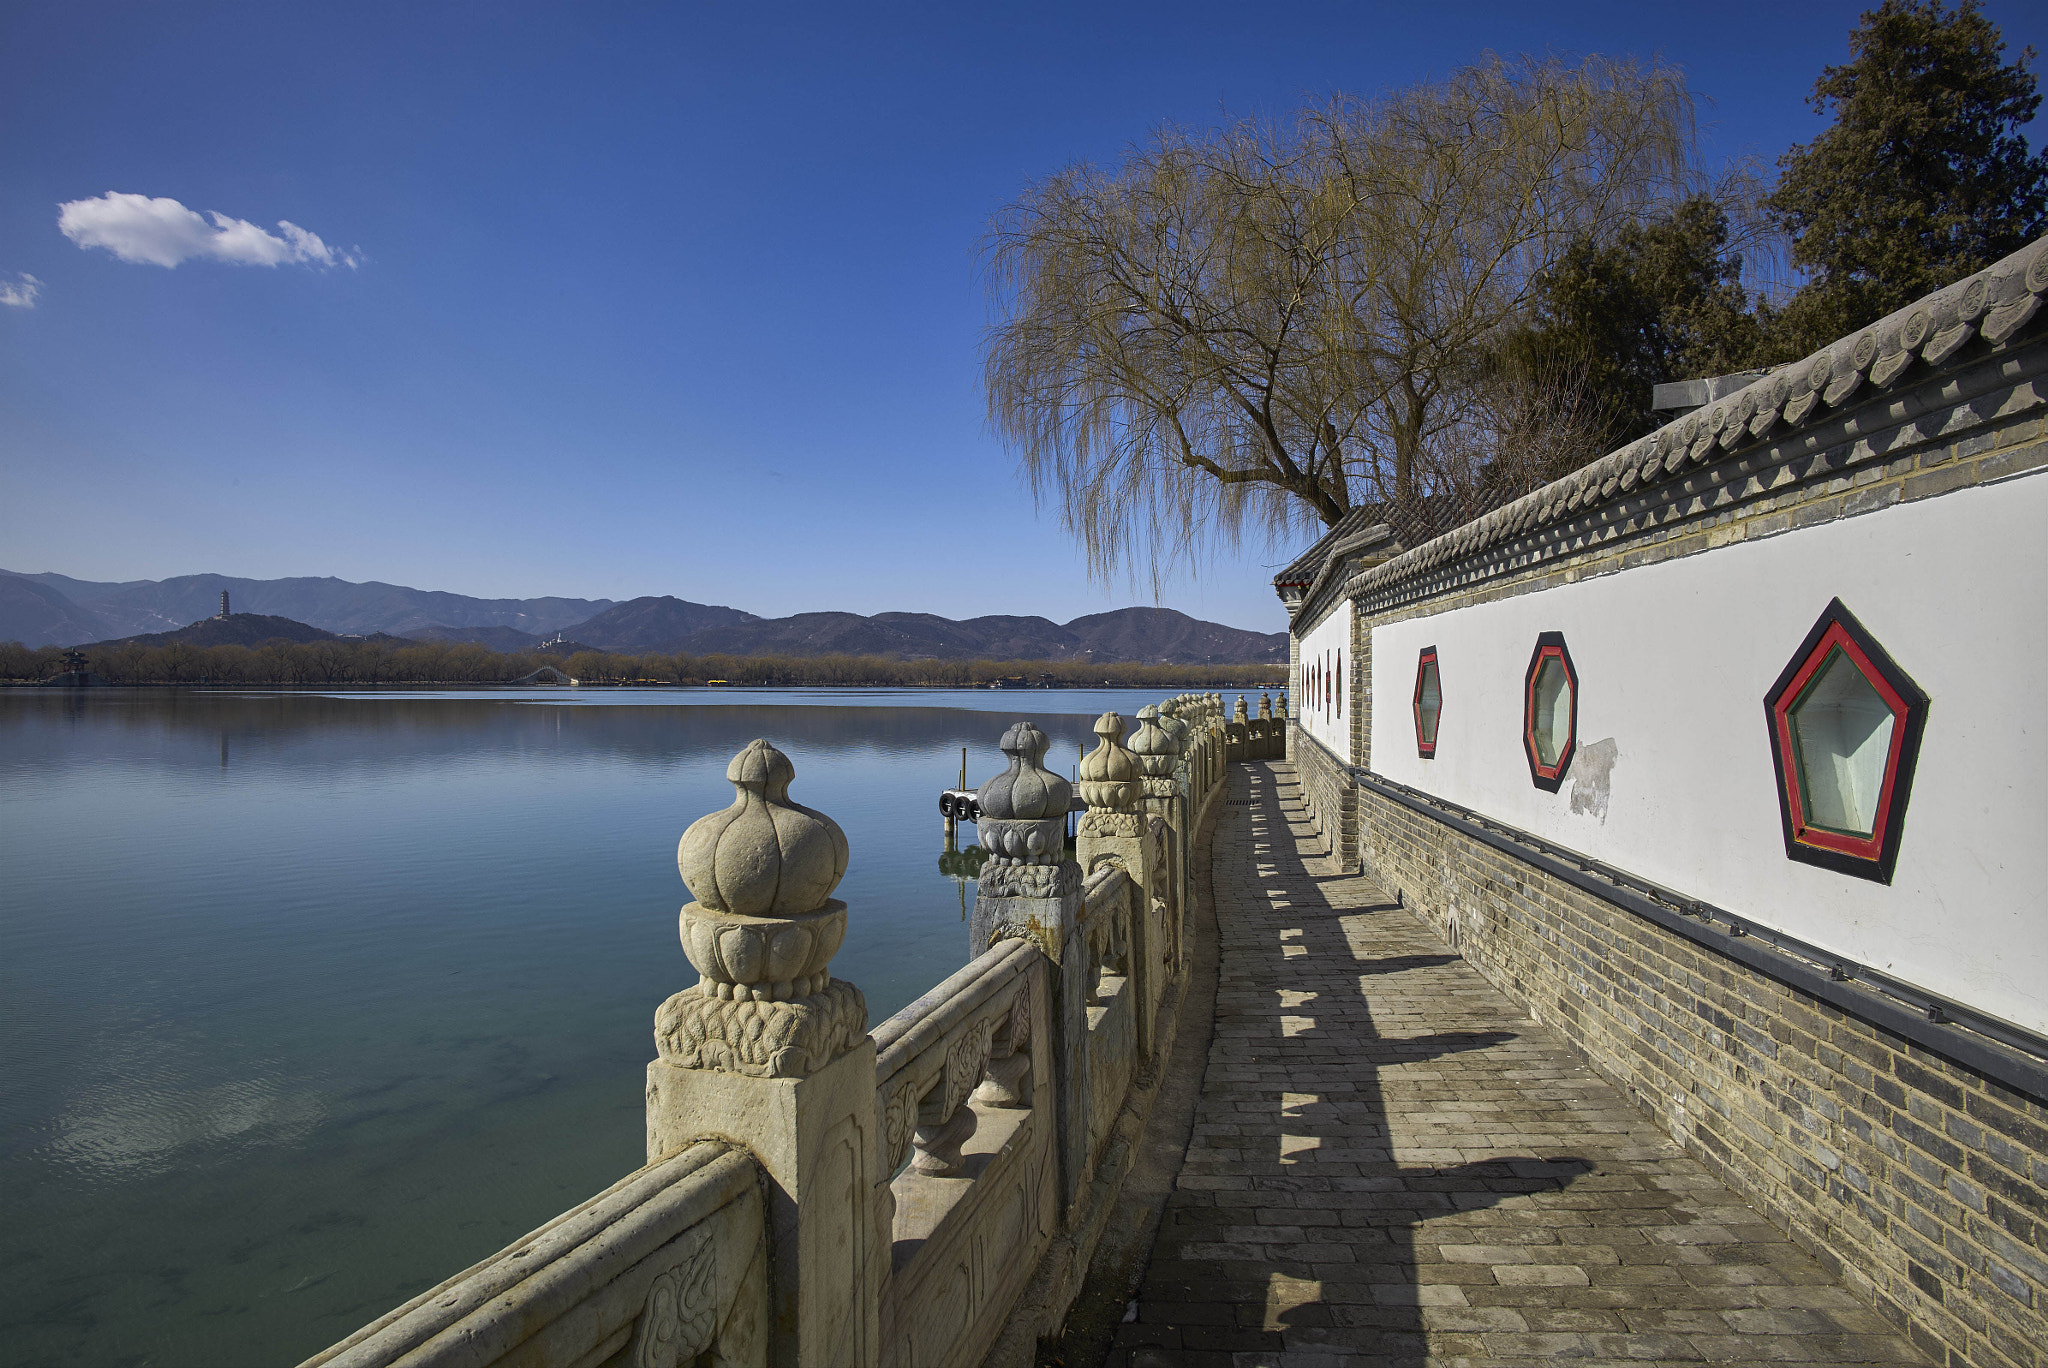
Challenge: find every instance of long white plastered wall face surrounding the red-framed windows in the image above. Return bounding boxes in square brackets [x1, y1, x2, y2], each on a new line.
[1368, 475, 2048, 1032]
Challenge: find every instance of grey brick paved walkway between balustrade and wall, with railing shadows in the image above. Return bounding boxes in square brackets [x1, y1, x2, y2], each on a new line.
[1108, 764, 1925, 1368]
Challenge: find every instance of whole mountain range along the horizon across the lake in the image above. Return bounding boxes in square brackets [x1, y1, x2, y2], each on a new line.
[0, 569, 1286, 666]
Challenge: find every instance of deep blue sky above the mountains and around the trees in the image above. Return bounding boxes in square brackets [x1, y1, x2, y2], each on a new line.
[0, 0, 2048, 631]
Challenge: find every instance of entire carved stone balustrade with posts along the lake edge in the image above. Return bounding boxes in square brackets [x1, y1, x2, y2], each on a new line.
[303, 694, 1228, 1368]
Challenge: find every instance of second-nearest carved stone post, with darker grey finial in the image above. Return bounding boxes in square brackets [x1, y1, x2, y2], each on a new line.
[963, 723, 1094, 1212]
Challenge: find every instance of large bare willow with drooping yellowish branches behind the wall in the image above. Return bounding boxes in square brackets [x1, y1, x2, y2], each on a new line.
[985, 57, 1694, 586]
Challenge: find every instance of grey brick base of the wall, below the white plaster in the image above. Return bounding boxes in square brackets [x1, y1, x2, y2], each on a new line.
[1358, 790, 2048, 1368]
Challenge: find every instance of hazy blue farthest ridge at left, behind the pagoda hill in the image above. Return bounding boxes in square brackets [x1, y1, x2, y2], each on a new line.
[0, 569, 612, 645]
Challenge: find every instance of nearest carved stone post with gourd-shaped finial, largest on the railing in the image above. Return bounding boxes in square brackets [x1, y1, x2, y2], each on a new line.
[647, 741, 887, 1368]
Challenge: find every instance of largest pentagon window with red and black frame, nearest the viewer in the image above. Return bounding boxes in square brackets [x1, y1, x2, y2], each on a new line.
[1763, 598, 1927, 883]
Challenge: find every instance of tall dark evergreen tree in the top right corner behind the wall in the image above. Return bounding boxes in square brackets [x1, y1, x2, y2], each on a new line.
[1765, 0, 2048, 354]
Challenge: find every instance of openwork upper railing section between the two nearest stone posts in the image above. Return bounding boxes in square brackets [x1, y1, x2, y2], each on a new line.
[874, 940, 1044, 1178]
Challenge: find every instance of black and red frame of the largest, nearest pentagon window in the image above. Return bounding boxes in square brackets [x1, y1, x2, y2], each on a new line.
[1763, 598, 1927, 883]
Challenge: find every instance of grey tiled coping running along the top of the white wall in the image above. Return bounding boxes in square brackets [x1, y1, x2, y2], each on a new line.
[1327, 238, 2048, 604]
